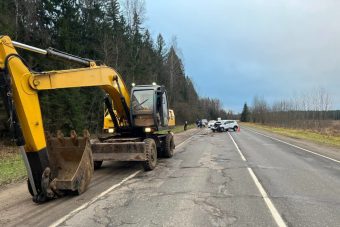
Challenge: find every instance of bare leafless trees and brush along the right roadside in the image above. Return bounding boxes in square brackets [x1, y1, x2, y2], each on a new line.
[240, 88, 340, 134]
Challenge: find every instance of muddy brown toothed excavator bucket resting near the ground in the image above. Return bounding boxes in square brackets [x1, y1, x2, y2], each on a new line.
[46, 130, 93, 194]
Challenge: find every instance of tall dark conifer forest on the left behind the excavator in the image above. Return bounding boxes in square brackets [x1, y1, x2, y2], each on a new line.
[0, 0, 226, 135]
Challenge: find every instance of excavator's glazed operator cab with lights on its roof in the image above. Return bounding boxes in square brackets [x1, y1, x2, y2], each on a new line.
[130, 85, 170, 132]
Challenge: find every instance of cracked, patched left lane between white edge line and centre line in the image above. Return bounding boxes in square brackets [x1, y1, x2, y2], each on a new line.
[61, 130, 275, 226]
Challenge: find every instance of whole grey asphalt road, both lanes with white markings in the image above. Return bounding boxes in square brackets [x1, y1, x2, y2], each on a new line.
[0, 129, 340, 226]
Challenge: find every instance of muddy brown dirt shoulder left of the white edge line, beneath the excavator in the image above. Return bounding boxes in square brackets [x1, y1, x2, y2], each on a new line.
[0, 129, 198, 227]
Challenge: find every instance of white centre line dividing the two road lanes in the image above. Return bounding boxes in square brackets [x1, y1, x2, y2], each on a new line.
[228, 132, 287, 227]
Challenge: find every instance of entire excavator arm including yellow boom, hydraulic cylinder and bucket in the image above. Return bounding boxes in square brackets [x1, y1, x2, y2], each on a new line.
[0, 36, 131, 201]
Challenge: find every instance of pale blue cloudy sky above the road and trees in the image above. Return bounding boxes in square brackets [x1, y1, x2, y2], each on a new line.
[145, 0, 340, 112]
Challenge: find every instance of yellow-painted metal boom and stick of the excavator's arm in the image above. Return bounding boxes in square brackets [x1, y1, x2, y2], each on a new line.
[0, 36, 130, 151]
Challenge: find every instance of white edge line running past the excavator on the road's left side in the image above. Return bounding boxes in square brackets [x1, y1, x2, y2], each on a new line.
[49, 132, 198, 227]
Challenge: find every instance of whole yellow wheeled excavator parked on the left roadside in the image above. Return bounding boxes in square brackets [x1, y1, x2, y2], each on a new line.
[0, 36, 175, 203]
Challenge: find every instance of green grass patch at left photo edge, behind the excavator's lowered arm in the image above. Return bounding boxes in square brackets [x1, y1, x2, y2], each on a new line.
[0, 148, 27, 186]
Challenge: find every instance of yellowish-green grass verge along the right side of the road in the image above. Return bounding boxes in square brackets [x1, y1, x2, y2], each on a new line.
[241, 123, 340, 148]
